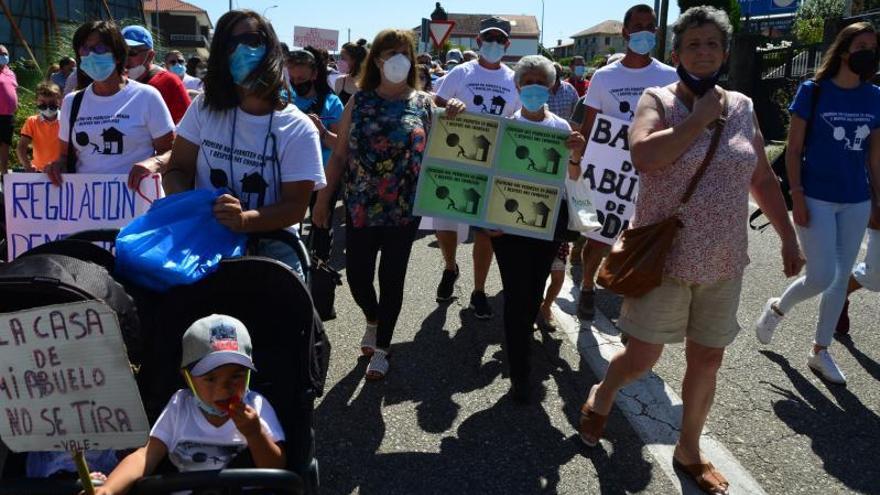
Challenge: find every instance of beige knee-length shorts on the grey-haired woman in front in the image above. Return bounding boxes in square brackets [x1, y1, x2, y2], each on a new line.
[618, 277, 742, 348]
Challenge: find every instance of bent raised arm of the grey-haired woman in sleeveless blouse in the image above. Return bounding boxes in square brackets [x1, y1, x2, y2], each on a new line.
[629, 92, 721, 172]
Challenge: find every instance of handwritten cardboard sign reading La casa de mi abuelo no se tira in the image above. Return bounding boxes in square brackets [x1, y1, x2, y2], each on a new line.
[0, 301, 150, 452]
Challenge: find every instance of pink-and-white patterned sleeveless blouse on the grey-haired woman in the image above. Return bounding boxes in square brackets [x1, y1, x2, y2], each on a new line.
[632, 87, 757, 284]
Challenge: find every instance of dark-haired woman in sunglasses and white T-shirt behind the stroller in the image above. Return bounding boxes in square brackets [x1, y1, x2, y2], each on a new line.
[163, 10, 325, 276]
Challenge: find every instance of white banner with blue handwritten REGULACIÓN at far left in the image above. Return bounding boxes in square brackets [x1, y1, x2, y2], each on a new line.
[3, 173, 165, 260]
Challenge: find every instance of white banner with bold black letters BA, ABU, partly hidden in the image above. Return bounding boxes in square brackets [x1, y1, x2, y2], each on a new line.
[581, 114, 639, 244]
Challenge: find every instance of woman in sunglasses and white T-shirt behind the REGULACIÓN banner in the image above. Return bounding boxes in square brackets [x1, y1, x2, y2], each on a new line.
[44, 21, 174, 189]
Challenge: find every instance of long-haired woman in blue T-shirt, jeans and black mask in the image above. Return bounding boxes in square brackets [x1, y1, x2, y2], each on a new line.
[755, 22, 880, 384]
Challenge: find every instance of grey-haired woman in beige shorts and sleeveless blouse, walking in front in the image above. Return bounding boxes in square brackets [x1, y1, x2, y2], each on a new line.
[579, 7, 803, 494]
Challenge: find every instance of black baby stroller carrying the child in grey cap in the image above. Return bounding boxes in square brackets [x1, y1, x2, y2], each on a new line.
[0, 231, 330, 495]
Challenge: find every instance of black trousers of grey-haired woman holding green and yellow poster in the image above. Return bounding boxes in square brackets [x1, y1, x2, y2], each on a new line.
[492, 235, 560, 383]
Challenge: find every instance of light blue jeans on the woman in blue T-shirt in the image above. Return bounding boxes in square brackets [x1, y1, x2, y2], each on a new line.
[778, 197, 871, 347]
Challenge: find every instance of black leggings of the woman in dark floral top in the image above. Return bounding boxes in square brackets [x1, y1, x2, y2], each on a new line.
[345, 218, 419, 350]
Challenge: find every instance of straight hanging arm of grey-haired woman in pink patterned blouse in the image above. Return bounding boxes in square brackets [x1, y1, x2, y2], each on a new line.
[750, 114, 804, 277]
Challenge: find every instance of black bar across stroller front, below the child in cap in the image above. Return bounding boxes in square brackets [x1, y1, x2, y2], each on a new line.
[129, 469, 304, 495]
